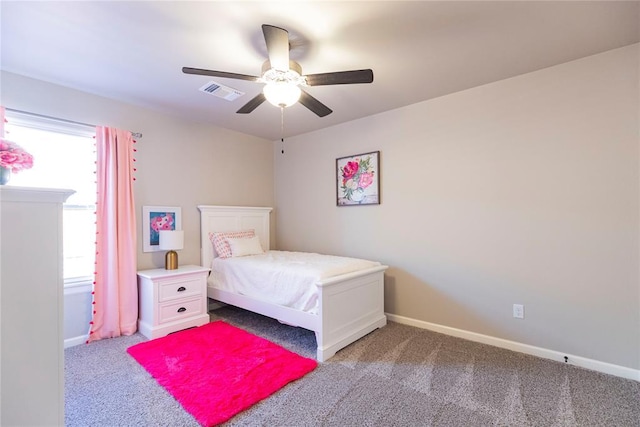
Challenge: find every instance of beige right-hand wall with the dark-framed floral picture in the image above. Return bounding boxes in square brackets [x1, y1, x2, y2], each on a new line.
[274, 45, 640, 369]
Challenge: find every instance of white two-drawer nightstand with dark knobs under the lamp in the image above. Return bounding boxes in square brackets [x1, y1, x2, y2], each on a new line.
[138, 265, 209, 339]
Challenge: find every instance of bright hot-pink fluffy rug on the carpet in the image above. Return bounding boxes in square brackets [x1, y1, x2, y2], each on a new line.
[127, 321, 317, 426]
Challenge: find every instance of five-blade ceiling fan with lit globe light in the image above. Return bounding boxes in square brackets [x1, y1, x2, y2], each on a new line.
[182, 24, 373, 117]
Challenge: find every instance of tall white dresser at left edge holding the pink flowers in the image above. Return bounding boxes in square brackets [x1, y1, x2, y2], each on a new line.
[0, 186, 74, 426]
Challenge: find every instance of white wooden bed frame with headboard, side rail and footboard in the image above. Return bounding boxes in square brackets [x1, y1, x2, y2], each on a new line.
[198, 205, 387, 362]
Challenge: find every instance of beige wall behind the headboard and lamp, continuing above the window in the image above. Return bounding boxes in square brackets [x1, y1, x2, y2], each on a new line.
[0, 72, 274, 269]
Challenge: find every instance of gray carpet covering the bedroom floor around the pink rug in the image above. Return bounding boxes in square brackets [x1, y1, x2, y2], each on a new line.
[65, 307, 640, 427]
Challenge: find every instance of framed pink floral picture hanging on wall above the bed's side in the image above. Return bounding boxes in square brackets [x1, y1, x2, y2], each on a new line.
[336, 151, 380, 206]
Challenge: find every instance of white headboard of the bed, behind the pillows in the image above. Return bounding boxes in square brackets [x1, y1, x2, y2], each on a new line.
[198, 205, 273, 267]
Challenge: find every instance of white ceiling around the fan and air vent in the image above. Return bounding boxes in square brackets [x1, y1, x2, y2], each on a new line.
[0, 0, 640, 140]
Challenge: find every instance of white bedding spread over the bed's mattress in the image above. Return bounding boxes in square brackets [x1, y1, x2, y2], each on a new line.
[209, 251, 381, 314]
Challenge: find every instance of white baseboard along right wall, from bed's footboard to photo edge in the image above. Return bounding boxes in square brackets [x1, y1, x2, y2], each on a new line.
[385, 313, 640, 381]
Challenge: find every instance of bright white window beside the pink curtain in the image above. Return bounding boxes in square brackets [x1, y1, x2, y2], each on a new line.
[5, 111, 96, 285]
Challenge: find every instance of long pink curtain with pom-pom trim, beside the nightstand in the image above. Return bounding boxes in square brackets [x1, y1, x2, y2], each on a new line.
[87, 126, 138, 342]
